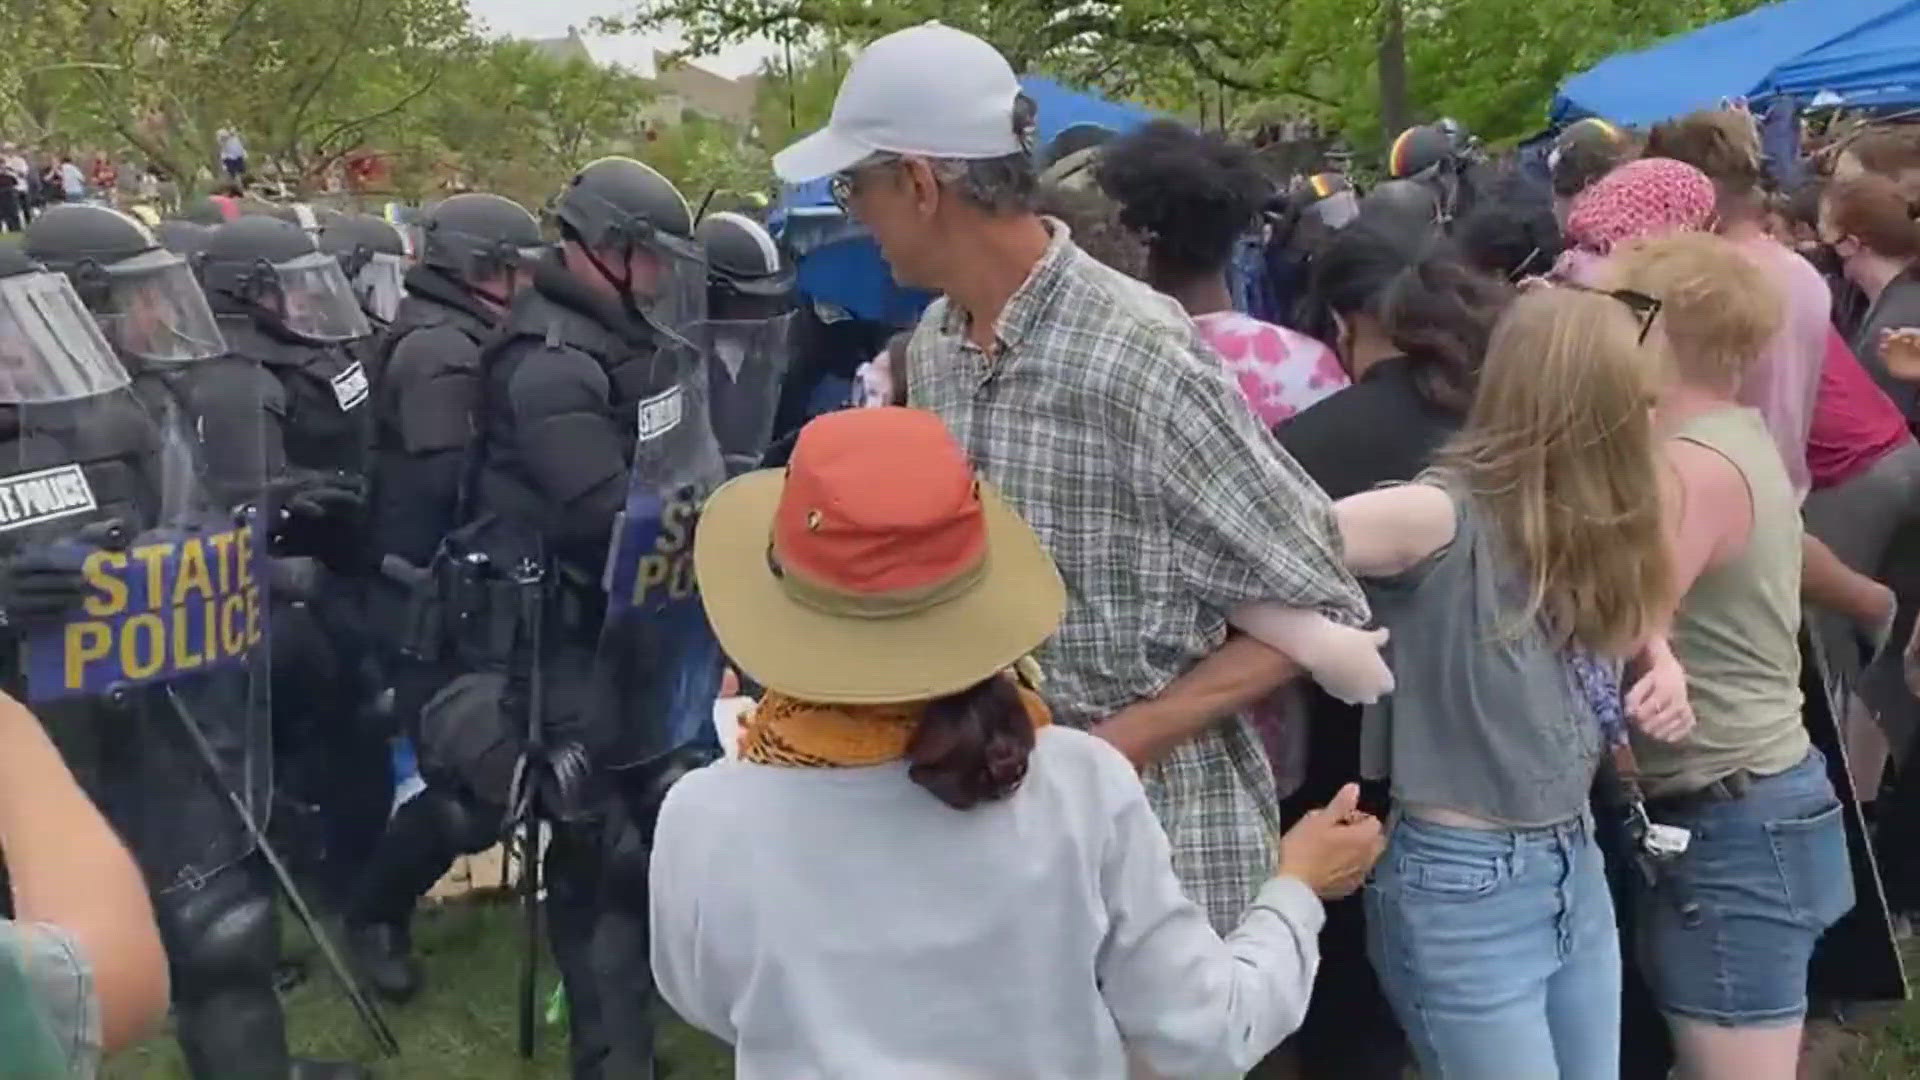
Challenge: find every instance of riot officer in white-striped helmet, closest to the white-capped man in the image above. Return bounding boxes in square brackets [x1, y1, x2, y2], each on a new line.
[695, 211, 799, 477]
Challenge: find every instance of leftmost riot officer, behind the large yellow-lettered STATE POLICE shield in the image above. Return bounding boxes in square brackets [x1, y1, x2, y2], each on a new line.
[0, 237, 361, 1080]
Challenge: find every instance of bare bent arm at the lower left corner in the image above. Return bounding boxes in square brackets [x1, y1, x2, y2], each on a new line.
[0, 694, 167, 1053]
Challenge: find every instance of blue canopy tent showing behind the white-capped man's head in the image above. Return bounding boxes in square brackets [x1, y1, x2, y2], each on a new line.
[768, 75, 1154, 327]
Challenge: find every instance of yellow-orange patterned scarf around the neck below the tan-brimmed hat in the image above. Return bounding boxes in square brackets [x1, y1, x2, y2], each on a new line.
[739, 672, 1052, 769]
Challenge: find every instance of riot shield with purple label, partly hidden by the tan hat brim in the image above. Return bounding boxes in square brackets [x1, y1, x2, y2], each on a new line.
[589, 336, 726, 769]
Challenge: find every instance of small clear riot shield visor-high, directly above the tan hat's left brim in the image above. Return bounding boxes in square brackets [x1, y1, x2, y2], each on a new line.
[699, 311, 799, 479]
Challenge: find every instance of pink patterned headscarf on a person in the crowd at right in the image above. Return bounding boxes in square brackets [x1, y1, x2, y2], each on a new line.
[1553, 158, 1715, 284]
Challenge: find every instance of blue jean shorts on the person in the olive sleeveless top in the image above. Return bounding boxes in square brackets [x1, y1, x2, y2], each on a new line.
[1636, 751, 1853, 1028]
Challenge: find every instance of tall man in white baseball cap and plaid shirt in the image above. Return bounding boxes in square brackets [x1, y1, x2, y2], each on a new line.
[774, 23, 1367, 1022]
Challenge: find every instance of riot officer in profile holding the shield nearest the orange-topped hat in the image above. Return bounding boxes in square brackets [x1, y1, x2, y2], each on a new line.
[456, 158, 724, 1080]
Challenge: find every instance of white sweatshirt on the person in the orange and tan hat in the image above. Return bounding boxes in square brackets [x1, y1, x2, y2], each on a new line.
[651, 726, 1325, 1080]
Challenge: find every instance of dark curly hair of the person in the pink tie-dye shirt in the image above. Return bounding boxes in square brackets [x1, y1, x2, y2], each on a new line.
[1094, 119, 1273, 279]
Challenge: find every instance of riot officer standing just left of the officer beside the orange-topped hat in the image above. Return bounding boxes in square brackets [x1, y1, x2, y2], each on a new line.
[348, 194, 541, 999]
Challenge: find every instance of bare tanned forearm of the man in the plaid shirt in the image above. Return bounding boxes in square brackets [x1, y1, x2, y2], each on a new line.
[1092, 636, 1300, 769]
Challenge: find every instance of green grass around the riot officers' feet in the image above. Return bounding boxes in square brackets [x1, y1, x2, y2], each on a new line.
[106, 901, 733, 1080]
